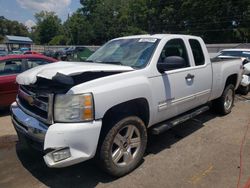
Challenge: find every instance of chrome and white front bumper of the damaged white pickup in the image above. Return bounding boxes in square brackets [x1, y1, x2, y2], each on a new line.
[11, 103, 102, 168]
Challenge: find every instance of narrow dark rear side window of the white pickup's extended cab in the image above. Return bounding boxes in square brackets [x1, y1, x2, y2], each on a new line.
[189, 39, 205, 66]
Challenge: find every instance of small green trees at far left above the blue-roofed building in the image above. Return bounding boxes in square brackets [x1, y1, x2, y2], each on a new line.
[0, 16, 28, 42]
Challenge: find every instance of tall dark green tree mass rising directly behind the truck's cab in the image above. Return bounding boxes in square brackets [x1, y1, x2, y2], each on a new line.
[80, 0, 250, 43]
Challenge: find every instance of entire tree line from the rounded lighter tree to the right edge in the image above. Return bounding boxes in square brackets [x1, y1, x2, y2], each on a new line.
[23, 0, 250, 45]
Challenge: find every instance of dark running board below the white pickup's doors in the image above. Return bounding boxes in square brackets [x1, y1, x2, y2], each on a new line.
[151, 106, 209, 135]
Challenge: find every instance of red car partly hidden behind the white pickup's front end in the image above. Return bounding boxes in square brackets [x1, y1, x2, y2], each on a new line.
[0, 54, 58, 108]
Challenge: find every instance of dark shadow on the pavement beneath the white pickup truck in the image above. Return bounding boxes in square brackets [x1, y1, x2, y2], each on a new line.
[16, 112, 216, 187]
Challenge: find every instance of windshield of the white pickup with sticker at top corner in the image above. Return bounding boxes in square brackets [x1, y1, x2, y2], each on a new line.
[87, 38, 158, 68]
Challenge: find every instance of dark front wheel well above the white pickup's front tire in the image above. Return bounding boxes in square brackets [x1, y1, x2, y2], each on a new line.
[103, 98, 150, 127]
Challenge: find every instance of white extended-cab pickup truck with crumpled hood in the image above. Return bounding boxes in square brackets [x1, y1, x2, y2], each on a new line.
[11, 34, 242, 176]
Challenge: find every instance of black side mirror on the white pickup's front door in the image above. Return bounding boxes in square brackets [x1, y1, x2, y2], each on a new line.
[157, 56, 187, 73]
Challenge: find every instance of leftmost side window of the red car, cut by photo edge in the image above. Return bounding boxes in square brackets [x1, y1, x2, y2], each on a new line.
[0, 60, 22, 76]
